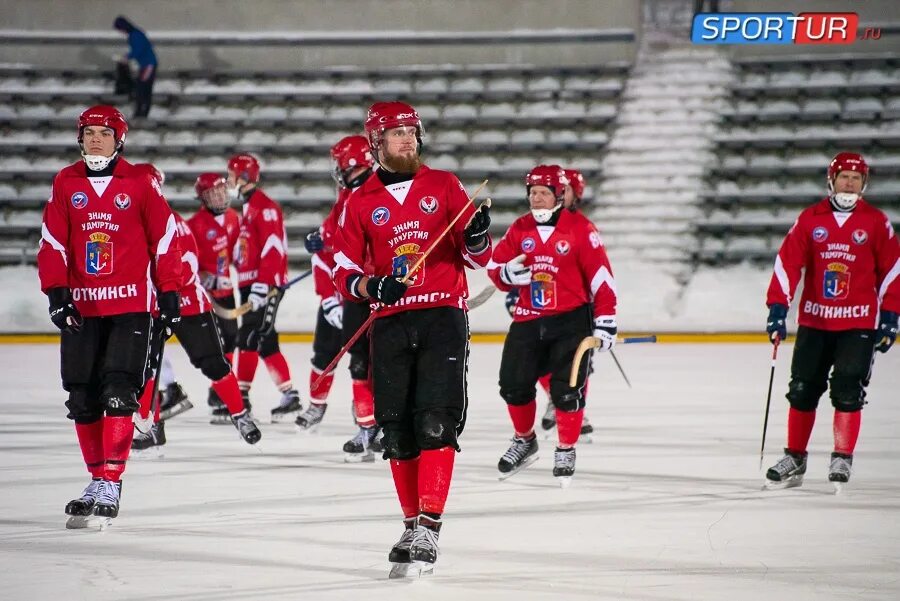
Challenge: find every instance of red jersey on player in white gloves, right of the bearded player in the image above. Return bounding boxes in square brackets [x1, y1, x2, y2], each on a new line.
[488, 209, 616, 321]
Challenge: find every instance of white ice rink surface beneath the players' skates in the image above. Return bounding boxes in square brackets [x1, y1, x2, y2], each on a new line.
[0, 344, 900, 601]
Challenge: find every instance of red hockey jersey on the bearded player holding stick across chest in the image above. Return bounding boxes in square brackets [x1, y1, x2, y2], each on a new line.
[334, 166, 491, 316]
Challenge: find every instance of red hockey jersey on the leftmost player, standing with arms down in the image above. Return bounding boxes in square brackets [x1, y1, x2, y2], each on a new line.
[37, 158, 182, 317]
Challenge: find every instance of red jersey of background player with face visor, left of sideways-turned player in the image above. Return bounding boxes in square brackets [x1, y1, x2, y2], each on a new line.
[187, 207, 241, 298]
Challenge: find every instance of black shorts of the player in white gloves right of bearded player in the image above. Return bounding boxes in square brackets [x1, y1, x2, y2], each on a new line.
[500, 305, 593, 411]
